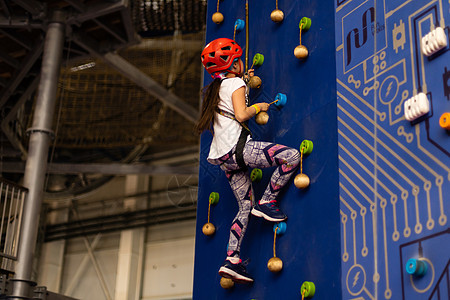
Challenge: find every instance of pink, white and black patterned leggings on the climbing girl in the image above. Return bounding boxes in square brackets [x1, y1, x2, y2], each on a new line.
[214, 140, 300, 257]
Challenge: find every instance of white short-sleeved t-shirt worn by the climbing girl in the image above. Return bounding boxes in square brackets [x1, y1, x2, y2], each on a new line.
[208, 77, 250, 163]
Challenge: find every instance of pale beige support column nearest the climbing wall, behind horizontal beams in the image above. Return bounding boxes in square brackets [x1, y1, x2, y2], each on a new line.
[114, 175, 146, 300]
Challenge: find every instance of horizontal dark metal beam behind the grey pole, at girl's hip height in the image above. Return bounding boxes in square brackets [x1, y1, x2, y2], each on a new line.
[2, 161, 198, 175]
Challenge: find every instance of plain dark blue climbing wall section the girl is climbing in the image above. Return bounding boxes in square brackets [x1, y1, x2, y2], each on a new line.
[194, 0, 341, 300]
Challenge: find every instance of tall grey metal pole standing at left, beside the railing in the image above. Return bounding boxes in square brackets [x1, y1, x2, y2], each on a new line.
[12, 11, 65, 299]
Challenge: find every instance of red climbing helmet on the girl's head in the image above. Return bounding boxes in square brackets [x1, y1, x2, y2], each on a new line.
[202, 38, 242, 75]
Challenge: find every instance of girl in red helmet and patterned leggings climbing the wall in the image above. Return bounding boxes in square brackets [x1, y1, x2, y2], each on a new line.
[196, 38, 300, 283]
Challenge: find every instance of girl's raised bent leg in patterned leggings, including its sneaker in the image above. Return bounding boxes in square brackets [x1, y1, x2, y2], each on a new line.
[244, 141, 300, 221]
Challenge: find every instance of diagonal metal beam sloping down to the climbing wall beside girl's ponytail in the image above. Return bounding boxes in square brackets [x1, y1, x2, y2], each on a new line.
[73, 33, 199, 123]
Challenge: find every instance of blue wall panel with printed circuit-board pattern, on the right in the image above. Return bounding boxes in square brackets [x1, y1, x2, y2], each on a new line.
[338, 0, 450, 300]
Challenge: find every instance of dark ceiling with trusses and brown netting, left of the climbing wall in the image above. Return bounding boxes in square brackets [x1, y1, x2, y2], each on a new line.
[0, 0, 206, 197]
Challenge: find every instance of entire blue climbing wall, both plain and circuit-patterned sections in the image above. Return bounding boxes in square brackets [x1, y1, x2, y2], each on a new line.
[194, 0, 450, 300]
